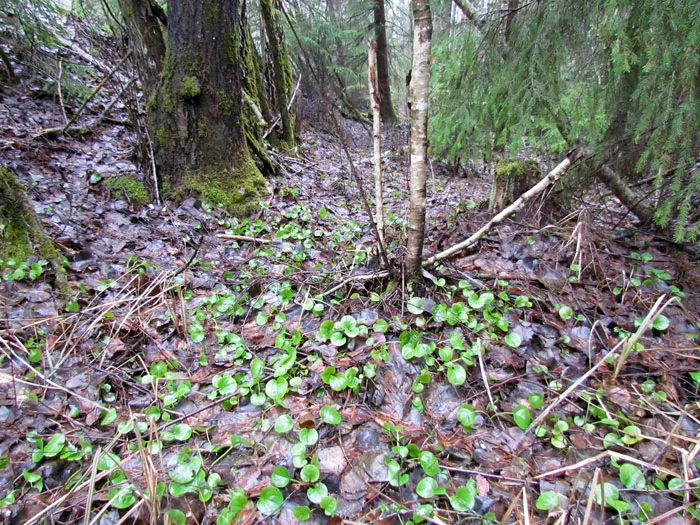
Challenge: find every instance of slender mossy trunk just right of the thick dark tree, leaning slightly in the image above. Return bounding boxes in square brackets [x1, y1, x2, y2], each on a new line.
[260, 0, 294, 147]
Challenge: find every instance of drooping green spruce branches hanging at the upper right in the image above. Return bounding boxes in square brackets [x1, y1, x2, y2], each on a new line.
[430, 0, 700, 241]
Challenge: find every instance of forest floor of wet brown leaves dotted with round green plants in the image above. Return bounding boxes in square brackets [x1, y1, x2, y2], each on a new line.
[0, 18, 700, 525]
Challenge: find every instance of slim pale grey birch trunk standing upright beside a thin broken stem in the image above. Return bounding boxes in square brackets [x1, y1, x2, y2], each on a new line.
[406, 0, 433, 278]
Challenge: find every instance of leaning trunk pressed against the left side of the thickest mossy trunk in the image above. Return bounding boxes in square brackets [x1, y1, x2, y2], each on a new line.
[119, 0, 166, 100]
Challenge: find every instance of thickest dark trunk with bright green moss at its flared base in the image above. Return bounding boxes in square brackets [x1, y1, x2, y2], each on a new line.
[149, 0, 265, 215]
